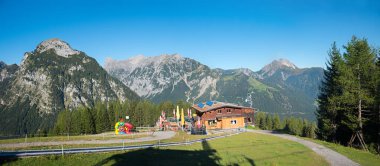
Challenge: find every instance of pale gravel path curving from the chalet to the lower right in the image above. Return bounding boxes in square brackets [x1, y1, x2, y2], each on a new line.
[247, 130, 359, 166]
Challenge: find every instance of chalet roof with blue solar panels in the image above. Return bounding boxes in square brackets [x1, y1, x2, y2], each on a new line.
[192, 101, 249, 112]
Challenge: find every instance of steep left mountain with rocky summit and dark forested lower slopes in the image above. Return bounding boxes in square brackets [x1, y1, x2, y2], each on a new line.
[0, 39, 139, 134]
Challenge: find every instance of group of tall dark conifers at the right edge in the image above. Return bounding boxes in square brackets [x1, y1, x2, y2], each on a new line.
[316, 36, 380, 153]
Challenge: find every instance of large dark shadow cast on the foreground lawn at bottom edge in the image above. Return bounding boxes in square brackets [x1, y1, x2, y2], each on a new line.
[96, 140, 255, 166]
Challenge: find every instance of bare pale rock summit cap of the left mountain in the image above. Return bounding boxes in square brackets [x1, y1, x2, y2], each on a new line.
[35, 38, 79, 58]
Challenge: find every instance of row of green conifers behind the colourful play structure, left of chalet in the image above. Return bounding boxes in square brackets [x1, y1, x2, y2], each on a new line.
[51, 100, 191, 135]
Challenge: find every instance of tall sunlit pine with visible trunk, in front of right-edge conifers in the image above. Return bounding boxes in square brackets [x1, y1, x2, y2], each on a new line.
[339, 37, 375, 149]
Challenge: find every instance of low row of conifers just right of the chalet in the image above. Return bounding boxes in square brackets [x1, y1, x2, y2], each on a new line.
[255, 112, 317, 138]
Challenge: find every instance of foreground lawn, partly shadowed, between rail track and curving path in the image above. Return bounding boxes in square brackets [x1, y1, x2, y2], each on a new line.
[2, 133, 328, 165]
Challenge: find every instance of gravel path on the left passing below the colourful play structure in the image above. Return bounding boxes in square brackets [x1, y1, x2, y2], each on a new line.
[0, 131, 175, 148]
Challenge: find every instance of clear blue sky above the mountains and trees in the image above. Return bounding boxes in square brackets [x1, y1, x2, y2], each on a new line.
[0, 0, 380, 71]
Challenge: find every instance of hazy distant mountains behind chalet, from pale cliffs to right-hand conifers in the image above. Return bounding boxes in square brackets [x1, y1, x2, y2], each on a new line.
[105, 55, 323, 118]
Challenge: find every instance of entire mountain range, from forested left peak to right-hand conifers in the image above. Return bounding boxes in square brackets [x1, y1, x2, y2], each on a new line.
[0, 39, 323, 134]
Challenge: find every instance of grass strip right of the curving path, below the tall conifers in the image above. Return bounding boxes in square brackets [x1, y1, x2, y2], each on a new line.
[302, 137, 380, 166]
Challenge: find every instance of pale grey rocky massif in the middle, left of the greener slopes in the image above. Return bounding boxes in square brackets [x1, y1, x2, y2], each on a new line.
[105, 55, 219, 102]
